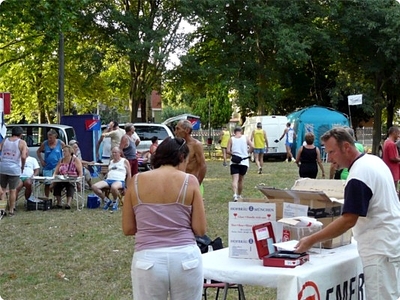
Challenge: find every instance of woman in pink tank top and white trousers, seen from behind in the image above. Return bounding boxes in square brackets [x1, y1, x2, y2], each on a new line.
[122, 138, 206, 300]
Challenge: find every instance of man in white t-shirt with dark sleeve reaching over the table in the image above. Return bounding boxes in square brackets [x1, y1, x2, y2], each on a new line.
[296, 127, 400, 300]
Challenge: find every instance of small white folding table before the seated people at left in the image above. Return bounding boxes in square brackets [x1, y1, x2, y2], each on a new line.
[33, 176, 85, 210]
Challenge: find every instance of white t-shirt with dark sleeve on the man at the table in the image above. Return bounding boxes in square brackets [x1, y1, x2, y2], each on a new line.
[343, 154, 400, 260]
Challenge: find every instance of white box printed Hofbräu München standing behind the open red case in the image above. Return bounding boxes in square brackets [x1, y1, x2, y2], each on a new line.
[228, 202, 282, 259]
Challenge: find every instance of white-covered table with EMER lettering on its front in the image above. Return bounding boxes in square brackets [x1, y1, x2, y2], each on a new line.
[203, 243, 365, 300]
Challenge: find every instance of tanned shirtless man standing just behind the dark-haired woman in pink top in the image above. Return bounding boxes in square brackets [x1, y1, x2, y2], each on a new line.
[175, 120, 207, 185]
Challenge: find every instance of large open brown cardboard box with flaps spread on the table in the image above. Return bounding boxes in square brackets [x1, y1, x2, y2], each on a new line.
[242, 178, 352, 249]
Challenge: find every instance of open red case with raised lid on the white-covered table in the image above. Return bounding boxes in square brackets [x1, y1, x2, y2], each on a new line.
[252, 222, 310, 268]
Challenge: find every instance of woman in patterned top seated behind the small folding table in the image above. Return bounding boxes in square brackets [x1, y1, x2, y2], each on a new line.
[53, 145, 82, 209]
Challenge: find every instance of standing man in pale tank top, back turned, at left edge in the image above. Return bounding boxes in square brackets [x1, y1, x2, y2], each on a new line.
[0, 126, 28, 217]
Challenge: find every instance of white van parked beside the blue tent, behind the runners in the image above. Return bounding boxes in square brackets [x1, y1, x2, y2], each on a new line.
[242, 115, 288, 160]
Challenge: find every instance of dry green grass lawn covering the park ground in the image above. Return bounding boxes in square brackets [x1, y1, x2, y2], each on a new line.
[0, 160, 328, 300]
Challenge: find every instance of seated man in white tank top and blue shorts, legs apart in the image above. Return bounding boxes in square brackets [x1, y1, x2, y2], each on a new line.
[92, 147, 131, 211]
